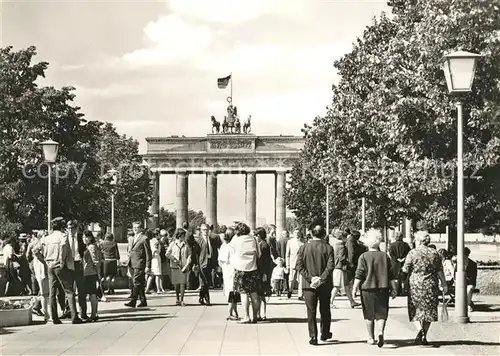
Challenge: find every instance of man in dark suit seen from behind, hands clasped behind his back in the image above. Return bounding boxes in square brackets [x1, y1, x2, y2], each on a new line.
[296, 225, 334, 345]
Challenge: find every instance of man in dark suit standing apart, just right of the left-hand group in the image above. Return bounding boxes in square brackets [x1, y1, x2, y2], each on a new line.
[125, 222, 151, 308]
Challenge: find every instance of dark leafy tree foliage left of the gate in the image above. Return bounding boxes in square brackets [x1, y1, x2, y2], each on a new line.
[0, 47, 149, 230]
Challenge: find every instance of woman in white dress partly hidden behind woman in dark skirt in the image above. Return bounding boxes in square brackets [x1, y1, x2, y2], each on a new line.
[218, 228, 241, 320]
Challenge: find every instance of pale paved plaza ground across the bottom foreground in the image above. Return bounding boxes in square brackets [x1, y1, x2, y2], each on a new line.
[0, 291, 500, 355]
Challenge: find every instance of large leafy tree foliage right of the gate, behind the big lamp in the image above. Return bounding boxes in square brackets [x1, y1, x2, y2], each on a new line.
[289, 0, 500, 230]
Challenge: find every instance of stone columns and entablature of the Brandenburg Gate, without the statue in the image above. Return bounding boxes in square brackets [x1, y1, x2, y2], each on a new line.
[143, 134, 304, 236]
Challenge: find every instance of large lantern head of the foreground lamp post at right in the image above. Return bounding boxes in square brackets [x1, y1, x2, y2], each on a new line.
[443, 51, 481, 94]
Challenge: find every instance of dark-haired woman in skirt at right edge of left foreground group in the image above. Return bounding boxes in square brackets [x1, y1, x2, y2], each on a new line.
[83, 231, 102, 322]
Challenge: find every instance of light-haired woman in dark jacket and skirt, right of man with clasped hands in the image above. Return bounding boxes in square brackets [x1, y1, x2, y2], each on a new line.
[352, 230, 397, 347]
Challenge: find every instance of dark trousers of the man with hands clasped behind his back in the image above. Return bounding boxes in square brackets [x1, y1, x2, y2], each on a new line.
[303, 286, 332, 338]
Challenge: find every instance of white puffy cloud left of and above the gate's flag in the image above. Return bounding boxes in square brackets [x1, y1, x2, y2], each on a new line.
[123, 14, 215, 66]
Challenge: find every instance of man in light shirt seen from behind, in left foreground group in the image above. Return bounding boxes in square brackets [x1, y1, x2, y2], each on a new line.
[42, 217, 83, 324]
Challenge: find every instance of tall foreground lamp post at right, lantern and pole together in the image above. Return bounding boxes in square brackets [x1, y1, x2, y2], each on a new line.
[443, 51, 481, 324]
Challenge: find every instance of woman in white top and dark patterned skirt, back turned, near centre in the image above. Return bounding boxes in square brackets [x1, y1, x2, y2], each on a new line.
[229, 223, 260, 324]
